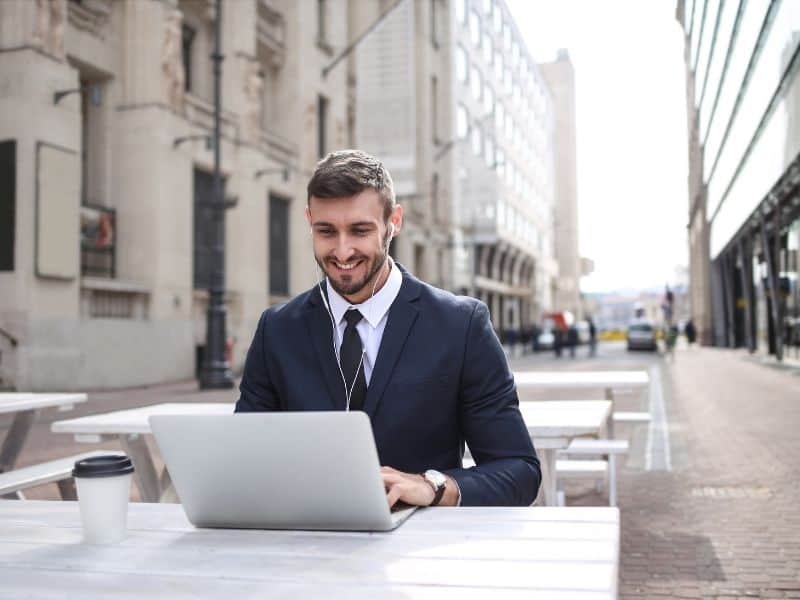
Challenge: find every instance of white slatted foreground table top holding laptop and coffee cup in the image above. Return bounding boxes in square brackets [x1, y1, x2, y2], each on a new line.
[0, 500, 619, 600]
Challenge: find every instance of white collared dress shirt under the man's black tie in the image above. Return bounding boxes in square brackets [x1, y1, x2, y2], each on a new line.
[325, 257, 403, 385]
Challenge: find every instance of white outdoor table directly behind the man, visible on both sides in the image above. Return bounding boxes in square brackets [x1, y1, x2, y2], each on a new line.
[51, 400, 611, 506]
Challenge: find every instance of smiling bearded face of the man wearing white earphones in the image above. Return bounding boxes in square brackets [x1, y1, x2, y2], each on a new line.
[306, 188, 402, 304]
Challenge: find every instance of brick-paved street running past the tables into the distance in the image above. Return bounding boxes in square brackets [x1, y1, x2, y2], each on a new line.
[3, 343, 800, 598]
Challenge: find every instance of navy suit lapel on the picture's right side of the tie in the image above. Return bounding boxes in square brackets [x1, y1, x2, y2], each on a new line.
[364, 268, 422, 419]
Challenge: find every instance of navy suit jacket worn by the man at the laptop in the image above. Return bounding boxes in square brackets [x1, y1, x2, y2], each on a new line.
[236, 269, 541, 506]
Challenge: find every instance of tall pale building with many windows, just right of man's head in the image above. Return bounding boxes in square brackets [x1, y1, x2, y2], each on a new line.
[356, 0, 558, 338]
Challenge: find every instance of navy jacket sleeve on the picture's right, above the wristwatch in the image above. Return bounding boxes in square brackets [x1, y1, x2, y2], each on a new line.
[447, 302, 541, 506]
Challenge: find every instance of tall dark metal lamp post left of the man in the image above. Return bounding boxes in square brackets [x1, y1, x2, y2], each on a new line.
[200, 0, 233, 389]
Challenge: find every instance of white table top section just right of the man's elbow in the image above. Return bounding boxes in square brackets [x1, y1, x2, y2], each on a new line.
[519, 400, 612, 441]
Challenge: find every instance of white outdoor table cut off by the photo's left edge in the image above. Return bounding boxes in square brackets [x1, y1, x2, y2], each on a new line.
[0, 392, 86, 473]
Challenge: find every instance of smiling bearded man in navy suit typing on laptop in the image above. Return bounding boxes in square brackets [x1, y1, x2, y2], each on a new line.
[236, 150, 541, 506]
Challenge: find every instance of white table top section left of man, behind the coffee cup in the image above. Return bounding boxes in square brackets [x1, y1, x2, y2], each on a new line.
[50, 402, 235, 435]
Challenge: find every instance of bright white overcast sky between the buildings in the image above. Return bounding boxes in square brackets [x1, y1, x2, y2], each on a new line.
[506, 0, 688, 292]
